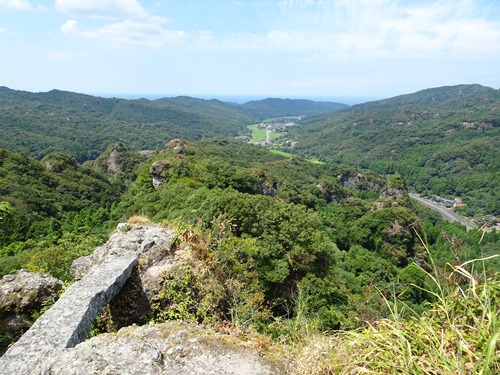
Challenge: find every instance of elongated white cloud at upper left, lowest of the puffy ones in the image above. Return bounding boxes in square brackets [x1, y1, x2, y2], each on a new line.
[61, 20, 186, 48]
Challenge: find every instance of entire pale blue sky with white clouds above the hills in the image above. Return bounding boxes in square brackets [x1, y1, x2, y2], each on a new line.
[0, 0, 500, 99]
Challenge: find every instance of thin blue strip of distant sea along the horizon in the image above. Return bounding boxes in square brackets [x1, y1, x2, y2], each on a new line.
[94, 93, 376, 105]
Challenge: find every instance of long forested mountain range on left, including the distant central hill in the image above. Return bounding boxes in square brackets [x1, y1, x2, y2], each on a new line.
[0, 87, 348, 162]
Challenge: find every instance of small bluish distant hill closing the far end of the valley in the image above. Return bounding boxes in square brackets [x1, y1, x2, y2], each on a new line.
[240, 98, 348, 120]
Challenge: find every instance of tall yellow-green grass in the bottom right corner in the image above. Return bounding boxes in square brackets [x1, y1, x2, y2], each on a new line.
[297, 251, 500, 375]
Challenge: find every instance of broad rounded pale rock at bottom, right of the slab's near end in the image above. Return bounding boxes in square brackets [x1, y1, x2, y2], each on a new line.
[36, 321, 285, 375]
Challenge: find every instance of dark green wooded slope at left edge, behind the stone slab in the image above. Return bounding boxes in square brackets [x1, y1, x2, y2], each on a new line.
[0, 149, 125, 280]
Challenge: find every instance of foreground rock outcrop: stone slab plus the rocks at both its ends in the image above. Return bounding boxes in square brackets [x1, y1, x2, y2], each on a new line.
[0, 224, 286, 375]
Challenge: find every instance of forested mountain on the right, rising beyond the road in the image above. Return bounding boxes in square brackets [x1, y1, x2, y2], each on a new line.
[290, 85, 500, 216]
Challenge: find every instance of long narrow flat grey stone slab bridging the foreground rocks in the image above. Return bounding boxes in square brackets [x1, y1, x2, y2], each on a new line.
[0, 256, 137, 375]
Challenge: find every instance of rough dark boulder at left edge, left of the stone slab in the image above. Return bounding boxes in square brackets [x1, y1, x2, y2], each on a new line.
[0, 270, 64, 352]
